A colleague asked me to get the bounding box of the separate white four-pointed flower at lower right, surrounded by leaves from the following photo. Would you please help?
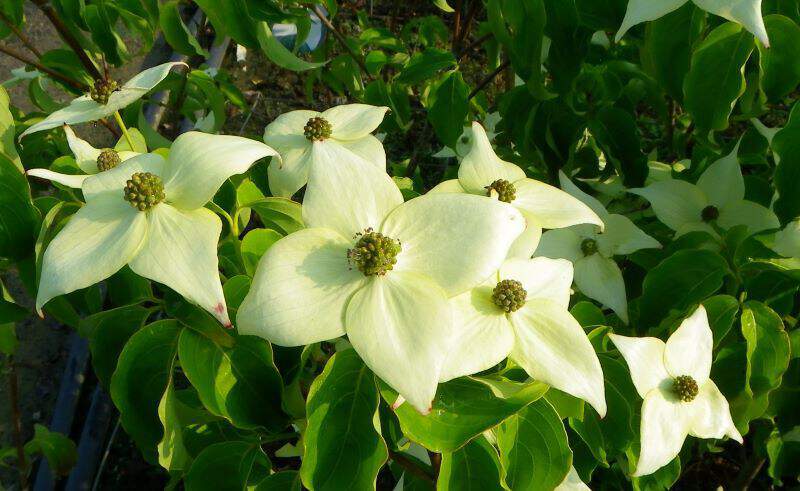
[609,305,742,476]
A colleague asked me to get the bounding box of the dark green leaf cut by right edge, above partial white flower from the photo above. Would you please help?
[772,103,800,224]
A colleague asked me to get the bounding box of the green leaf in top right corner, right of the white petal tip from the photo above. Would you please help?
[758,15,800,102]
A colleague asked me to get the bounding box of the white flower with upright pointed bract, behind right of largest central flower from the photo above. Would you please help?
[430,123,603,258]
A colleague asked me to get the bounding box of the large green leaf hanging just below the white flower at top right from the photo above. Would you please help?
[683,22,754,131]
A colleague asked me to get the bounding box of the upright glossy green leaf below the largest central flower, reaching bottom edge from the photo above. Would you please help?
[300,349,389,491]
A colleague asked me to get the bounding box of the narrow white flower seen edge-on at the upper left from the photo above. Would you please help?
[20,62,186,138]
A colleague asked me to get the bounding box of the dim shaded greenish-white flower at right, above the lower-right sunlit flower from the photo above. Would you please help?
[629,144,780,237]
